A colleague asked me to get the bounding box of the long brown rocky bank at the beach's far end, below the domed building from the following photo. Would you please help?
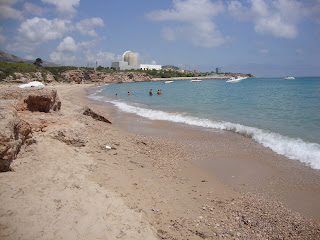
[62,69,151,84]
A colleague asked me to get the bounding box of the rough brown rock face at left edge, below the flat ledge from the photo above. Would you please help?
[0,106,32,172]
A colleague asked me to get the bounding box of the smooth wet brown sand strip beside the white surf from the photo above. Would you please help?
[88,86,320,221]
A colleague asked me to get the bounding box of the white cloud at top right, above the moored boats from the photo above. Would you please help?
[228,0,307,39]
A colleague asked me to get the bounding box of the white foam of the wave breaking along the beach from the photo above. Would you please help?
[110,101,320,169]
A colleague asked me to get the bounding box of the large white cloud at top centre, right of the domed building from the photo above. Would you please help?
[147,0,226,48]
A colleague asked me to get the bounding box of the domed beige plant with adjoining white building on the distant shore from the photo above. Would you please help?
[111,51,162,70]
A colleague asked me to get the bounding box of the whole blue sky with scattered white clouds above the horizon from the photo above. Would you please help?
[0,0,320,77]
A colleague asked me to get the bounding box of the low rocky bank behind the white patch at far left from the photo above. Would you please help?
[3,72,54,83]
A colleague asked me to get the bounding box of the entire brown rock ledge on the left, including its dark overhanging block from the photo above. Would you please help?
[0,87,61,171]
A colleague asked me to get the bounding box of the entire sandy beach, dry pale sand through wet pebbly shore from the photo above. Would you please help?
[0,84,320,239]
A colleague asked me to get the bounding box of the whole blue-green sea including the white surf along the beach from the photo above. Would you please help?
[91,77,320,169]
